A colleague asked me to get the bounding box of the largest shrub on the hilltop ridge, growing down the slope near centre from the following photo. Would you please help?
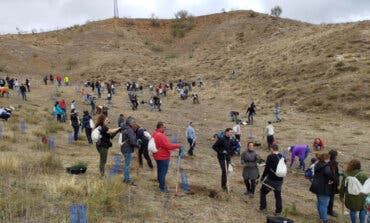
[171,10,195,38]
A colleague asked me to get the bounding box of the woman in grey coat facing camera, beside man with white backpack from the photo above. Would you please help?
[241,142,262,198]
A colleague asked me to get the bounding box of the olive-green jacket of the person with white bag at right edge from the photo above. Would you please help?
[339,170,368,211]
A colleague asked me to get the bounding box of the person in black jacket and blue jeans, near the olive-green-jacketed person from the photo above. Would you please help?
[310,153,334,223]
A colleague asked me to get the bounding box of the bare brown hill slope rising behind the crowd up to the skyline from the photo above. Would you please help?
[0,11,370,118]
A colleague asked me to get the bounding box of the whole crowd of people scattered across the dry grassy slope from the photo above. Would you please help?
[0,75,368,223]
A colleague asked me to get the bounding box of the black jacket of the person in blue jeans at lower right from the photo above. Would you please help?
[310,162,334,196]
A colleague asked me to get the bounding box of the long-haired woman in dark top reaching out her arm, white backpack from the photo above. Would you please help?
[95,114,121,176]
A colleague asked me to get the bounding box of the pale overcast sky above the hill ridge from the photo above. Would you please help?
[0,0,370,34]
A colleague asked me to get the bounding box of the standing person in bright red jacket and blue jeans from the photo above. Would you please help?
[152,122,181,193]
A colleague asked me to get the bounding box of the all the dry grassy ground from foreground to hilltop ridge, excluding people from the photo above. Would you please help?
[0,11,370,223]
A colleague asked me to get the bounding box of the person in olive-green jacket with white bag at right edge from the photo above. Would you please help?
[339,159,368,223]
